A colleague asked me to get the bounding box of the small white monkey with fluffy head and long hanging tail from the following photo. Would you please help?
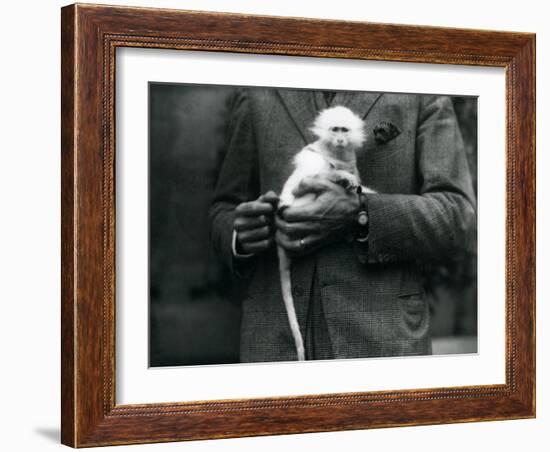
[277,106,374,361]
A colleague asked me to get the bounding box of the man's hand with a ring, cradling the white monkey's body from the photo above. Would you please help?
[275,177,359,255]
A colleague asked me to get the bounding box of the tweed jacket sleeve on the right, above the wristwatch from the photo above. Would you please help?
[367,96,477,262]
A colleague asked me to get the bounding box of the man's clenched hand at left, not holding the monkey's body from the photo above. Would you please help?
[233,191,279,254]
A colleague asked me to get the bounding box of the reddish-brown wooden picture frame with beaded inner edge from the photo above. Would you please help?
[61,4,535,447]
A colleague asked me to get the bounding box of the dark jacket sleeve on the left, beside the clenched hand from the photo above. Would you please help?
[209,89,259,277]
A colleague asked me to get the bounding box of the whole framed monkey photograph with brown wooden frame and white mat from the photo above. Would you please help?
[61,4,535,447]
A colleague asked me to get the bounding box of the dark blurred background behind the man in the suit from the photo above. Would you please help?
[149,83,477,367]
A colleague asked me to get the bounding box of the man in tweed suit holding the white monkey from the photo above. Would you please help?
[210,88,476,362]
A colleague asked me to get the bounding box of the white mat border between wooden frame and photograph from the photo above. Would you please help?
[116,48,506,404]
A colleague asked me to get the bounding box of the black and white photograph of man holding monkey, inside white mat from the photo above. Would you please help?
[148,85,478,367]
